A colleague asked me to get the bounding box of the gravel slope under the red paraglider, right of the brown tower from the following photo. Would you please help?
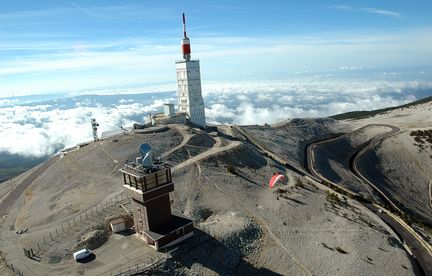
[169,138,413,275]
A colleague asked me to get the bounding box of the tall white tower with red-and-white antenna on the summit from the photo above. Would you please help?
[176,14,207,128]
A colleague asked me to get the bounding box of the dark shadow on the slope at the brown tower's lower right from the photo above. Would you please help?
[170,229,281,275]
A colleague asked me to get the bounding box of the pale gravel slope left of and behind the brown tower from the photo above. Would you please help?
[11,127,181,228]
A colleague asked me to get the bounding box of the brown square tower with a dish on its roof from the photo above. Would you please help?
[120,144,194,250]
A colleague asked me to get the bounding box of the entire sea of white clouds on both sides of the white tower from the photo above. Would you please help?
[0,80,432,157]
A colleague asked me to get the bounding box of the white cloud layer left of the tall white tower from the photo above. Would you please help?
[0,100,164,156]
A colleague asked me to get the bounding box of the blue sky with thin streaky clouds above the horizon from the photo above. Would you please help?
[0,0,432,97]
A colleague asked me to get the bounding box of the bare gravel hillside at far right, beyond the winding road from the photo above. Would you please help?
[350,102,432,226]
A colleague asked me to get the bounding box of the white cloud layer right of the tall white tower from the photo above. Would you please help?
[204,80,432,125]
